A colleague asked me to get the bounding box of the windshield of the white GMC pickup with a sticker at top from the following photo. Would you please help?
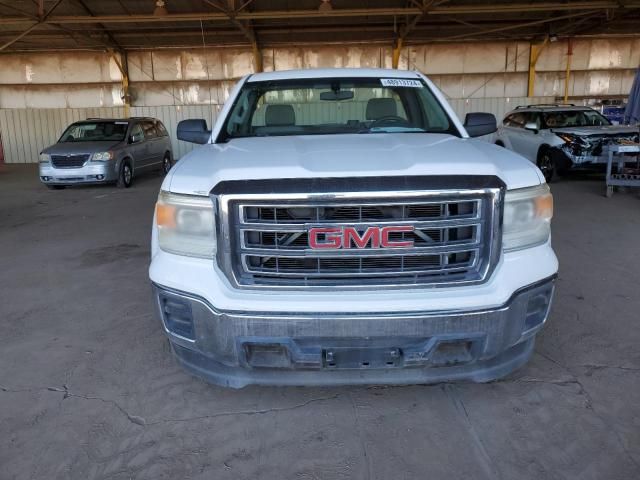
[218,78,459,141]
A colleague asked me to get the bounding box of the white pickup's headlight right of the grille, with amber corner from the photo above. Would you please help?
[502,183,553,251]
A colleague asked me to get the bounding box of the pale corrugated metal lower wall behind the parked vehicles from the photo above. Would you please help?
[0,97,553,163]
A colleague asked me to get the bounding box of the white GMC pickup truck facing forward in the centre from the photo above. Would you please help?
[149,69,558,387]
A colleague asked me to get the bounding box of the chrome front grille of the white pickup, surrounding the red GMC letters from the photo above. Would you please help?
[217,179,501,288]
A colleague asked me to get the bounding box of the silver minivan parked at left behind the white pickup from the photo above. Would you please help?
[40,117,173,189]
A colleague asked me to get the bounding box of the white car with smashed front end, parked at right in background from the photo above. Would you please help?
[495,105,638,182]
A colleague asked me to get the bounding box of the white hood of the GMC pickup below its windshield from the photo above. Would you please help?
[162,133,543,195]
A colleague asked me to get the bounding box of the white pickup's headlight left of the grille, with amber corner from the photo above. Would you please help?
[156,191,216,258]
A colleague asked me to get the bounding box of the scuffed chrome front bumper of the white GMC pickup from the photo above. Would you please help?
[153,278,554,388]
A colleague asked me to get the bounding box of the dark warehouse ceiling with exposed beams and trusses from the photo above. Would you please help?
[0,0,640,53]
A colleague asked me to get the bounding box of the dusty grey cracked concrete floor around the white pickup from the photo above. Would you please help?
[0,166,640,480]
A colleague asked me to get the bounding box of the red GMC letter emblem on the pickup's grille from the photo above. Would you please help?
[309,225,414,250]
